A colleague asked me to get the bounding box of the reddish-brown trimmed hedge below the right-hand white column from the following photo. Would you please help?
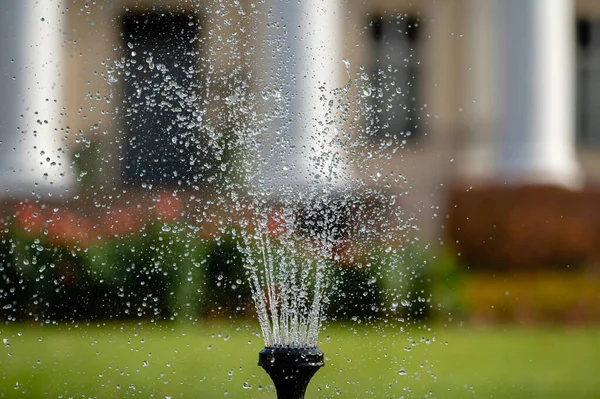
[446,186,600,270]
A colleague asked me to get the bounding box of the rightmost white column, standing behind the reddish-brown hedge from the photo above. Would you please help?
[496,0,581,186]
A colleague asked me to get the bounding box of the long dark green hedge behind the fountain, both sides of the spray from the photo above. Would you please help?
[0,211,436,320]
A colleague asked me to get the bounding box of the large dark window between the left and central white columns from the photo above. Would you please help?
[123,12,200,185]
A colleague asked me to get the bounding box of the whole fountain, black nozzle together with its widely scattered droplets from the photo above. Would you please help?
[0,0,426,399]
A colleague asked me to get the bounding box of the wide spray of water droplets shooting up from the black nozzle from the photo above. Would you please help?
[95,0,422,347]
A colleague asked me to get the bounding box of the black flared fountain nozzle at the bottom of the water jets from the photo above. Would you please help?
[258,347,325,399]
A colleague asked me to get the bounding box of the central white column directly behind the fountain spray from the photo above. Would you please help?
[258,0,348,195]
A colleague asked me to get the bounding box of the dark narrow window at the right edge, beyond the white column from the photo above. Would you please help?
[577,20,600,146]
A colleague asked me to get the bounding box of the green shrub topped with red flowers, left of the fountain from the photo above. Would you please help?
[0,196,207,319]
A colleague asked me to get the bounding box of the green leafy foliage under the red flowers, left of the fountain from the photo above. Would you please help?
[0,221,209,319]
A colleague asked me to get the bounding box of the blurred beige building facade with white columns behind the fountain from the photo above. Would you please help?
[0,0,600,236]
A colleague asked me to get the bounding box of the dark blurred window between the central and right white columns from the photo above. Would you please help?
[368,14,422,142]
